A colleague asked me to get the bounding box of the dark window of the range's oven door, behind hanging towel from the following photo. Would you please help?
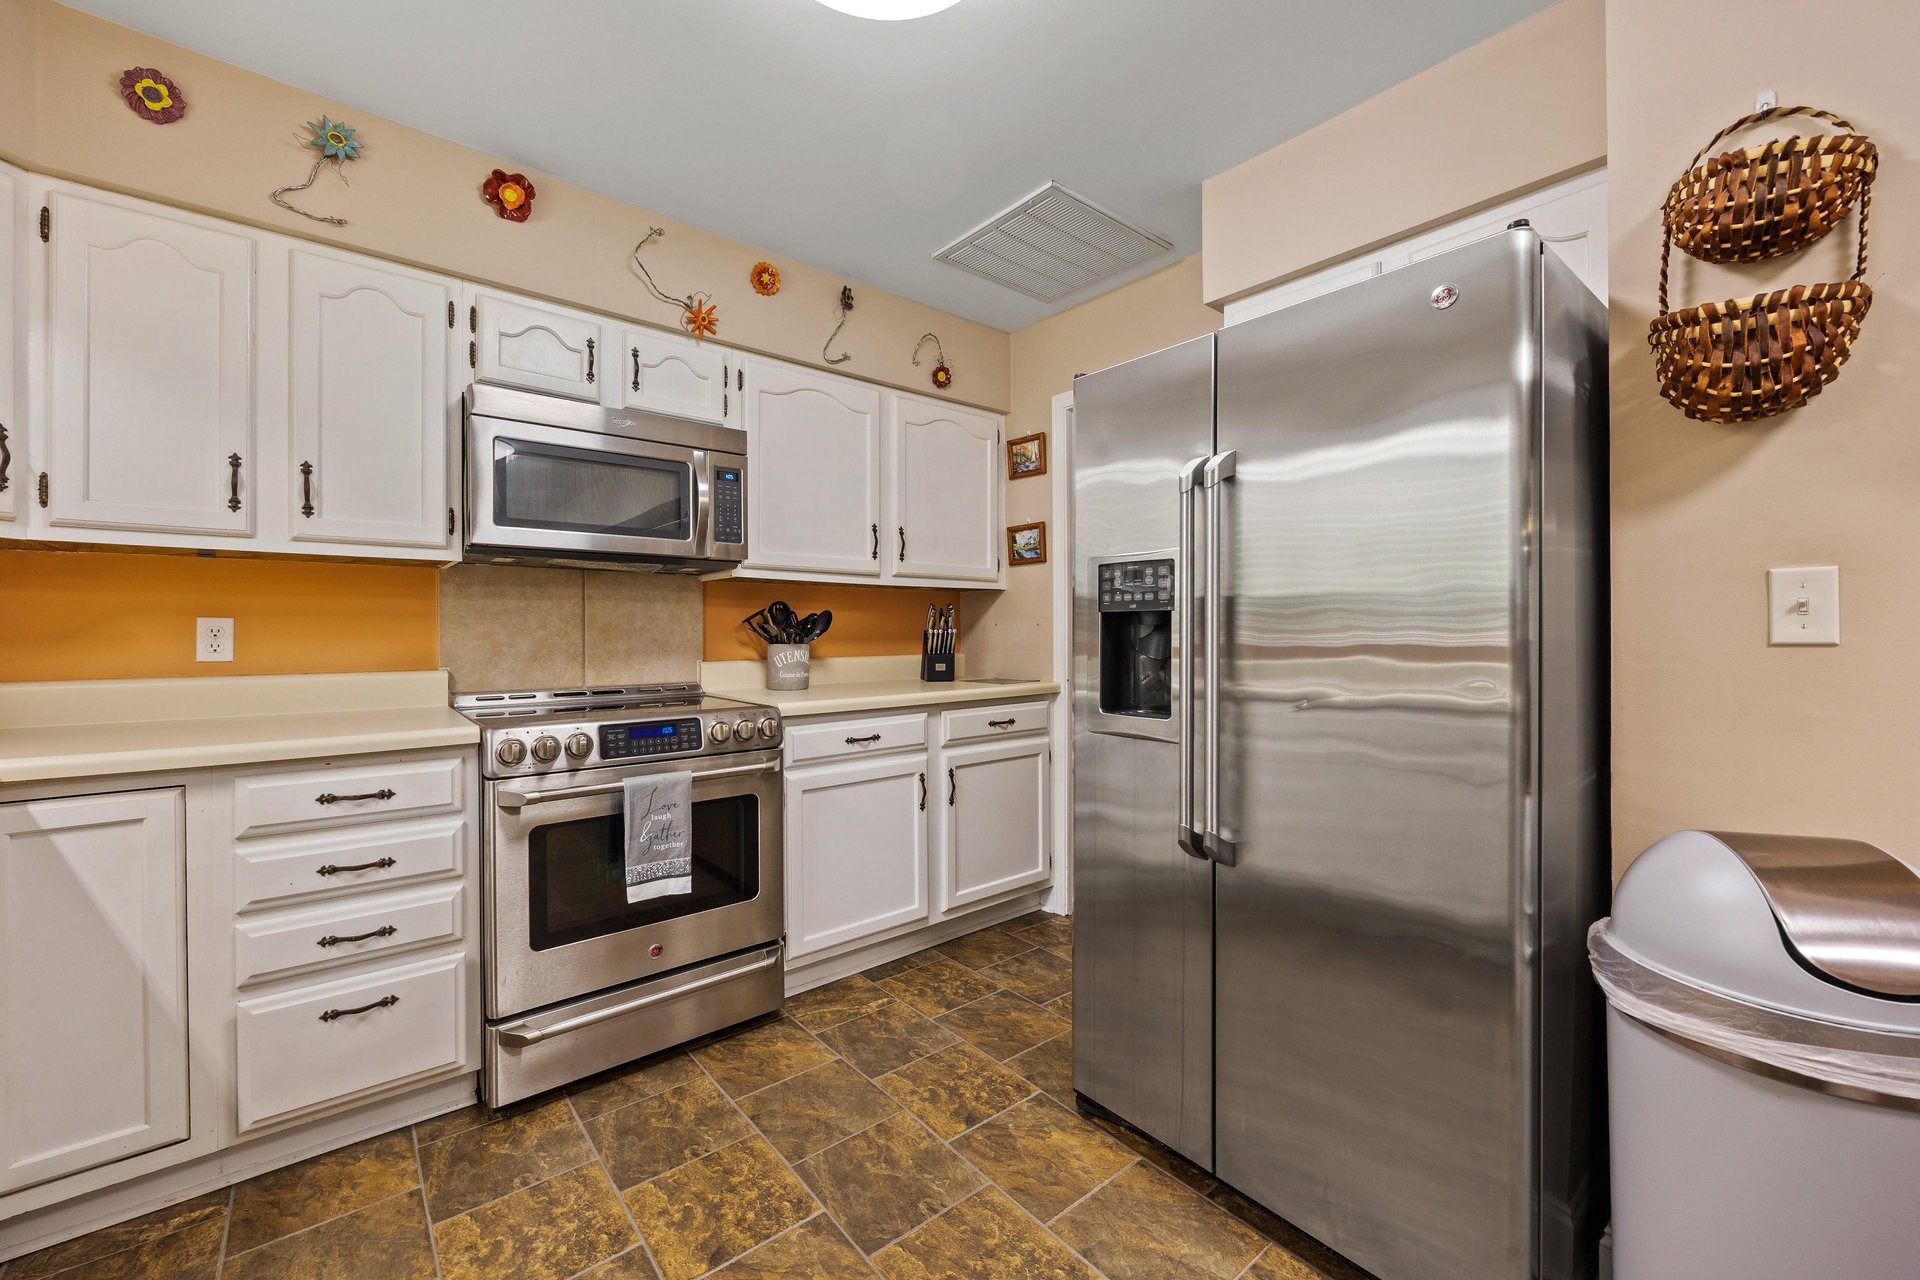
[526,794,760,952]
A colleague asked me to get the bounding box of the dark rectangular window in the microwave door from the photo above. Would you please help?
[493,439,693,541]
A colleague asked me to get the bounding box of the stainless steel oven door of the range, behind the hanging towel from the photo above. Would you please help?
[486,750,785,1019]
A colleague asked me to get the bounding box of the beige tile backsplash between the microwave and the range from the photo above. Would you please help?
[440,564,701,693]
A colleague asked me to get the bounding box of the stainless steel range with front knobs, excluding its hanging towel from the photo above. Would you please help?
[453,685,783,1107]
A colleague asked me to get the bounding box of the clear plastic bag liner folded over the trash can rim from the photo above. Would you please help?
[1586,919,1920,1107]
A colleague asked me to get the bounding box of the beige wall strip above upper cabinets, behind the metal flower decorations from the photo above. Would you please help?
[0,0,1008,409]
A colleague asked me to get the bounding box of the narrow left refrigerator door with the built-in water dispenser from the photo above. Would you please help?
[1073,338,1213,1165]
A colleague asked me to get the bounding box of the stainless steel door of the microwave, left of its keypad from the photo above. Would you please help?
[467,415,712,560]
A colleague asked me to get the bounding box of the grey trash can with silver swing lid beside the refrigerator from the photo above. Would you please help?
[1588,831,1920,1280]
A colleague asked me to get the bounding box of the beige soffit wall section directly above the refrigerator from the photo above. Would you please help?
[1202,0,1612,307]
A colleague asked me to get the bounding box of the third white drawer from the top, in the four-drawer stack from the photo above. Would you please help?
[234,881,465,986]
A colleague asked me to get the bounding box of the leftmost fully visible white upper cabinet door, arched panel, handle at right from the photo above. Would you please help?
[46,192,255,535]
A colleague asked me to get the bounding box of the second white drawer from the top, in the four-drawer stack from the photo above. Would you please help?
[234,818,467,912]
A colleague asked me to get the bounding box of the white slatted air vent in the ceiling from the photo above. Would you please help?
[933,182,1173,301]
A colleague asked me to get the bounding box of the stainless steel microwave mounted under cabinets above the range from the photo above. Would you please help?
[465,386,747,574]
